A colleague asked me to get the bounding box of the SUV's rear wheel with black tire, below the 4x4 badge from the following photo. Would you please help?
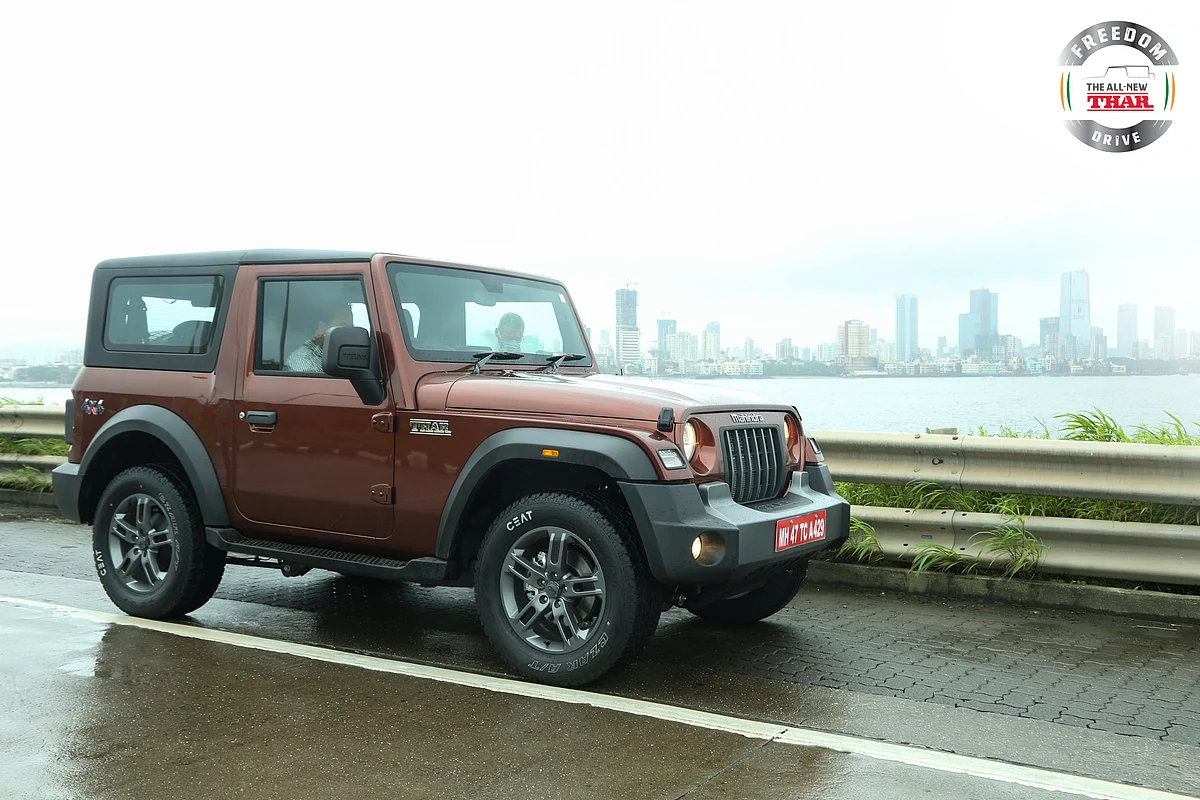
[91,467,226,619]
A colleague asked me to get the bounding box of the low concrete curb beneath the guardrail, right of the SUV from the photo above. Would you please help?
[808,561,1200,622]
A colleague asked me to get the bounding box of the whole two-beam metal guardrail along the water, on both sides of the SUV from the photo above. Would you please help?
[0,405,1200,585]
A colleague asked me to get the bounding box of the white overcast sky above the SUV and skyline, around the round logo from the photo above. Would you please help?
[0,0,1200,357]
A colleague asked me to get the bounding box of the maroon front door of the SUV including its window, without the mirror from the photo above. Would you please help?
[226,271,395,540]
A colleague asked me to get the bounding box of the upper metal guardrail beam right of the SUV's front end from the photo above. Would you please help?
[810,431,1200,505]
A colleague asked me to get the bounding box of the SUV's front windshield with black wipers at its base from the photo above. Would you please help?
[388,263,592,367]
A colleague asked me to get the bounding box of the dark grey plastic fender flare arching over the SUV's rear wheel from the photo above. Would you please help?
[79,404,229,525]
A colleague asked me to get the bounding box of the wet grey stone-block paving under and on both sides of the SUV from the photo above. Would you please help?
[9,521,1200,746]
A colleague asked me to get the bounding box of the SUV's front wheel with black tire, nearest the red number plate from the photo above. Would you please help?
[475,492,661,686]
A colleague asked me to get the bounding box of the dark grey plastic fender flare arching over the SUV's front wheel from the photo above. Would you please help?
[436,428,660,559]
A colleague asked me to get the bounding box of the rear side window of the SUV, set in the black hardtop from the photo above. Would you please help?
[104,276,223,353]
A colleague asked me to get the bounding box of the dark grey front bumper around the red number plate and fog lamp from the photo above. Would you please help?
[620,463,850,584]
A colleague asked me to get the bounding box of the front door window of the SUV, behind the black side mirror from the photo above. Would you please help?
[254,278,371,375]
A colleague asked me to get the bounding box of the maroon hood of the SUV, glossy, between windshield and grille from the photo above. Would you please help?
[446,372,791,421]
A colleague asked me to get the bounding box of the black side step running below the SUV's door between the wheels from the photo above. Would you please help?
[204,528,456,585]
